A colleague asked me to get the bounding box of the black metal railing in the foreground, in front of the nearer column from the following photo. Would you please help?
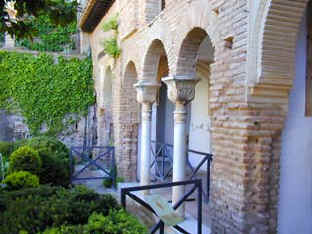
[121,180,202,234]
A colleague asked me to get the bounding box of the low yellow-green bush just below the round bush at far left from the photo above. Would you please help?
[3,171,39,191]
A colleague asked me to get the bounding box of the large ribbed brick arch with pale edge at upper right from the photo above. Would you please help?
[248,0,309,93]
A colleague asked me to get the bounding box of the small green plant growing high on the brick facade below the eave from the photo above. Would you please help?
[102,14,121,59]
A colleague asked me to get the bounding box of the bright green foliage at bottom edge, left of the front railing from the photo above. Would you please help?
[43,210,148,234]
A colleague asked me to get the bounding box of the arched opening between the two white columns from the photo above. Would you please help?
[143,39,174,180]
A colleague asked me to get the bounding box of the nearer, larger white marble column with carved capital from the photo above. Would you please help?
[162,76,199,216]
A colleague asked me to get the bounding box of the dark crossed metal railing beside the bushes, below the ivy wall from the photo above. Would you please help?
[70,146,116,185]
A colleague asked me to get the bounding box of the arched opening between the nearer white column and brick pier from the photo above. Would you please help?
[176,28,214,226]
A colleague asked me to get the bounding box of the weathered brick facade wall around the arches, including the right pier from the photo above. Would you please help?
[85,0,303,234]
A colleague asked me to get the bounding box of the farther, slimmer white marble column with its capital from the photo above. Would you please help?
[134,80,160,194]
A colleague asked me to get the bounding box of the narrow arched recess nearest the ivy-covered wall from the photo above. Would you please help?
[97,66,114,146]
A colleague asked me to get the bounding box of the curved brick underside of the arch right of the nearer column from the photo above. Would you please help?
[176,28,214,77]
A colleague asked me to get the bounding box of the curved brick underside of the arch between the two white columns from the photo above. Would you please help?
[142,39,167,81]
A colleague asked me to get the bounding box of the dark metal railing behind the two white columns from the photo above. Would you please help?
[151,141,213,202]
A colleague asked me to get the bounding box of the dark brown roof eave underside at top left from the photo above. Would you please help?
[79,0,115,33]
